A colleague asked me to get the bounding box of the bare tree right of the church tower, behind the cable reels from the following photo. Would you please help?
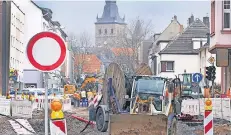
[112,17,152,73]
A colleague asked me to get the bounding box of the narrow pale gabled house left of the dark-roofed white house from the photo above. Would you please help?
[148,15,183,75]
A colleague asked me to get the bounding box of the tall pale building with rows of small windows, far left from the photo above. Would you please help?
[10,1,26,89]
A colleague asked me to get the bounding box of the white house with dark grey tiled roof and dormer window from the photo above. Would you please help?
[158,16,209,78]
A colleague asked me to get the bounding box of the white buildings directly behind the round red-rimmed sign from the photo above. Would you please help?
[19,1,69,88]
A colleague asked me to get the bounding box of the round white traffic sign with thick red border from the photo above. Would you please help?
[27,32,67,72]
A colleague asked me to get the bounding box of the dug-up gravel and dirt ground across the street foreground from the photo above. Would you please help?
[0,108,231,135]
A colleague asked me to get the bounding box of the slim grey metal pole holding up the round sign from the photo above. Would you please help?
[44,72,49,135]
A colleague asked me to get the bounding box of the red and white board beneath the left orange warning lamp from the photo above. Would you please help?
[50,119,67,135]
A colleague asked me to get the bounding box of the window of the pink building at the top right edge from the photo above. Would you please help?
[223,0,231,29]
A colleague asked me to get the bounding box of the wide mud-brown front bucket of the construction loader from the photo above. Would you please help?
[109,114,168,135]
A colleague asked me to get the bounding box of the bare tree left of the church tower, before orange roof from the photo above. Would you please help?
[68,32,92,80]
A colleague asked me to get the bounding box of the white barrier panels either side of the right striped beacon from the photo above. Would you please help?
[181,98,231,121]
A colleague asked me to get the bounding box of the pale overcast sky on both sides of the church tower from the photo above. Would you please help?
[35,0,210,40]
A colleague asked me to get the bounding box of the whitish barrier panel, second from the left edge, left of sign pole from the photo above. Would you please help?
[12,100,33,118]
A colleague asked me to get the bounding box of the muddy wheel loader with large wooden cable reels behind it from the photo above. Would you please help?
[92,63,181,135]
